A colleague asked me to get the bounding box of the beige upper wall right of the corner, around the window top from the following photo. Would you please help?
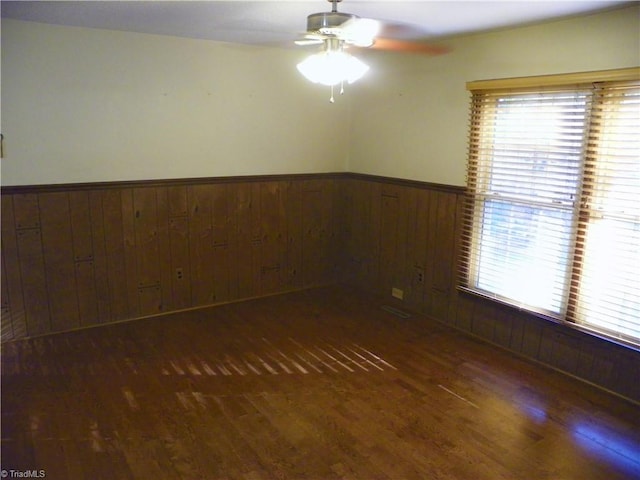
[347,4,640,185]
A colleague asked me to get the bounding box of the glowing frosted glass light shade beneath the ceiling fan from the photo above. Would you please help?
[297,50,369,86]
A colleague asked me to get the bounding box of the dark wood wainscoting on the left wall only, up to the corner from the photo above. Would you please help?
[2,174,340,341]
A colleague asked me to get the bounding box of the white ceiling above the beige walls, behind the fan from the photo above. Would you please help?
[1,0,630,46]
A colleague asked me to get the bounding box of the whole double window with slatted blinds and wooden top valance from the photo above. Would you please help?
[461,69,640,345]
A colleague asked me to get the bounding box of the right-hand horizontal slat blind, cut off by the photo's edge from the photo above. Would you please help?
[569,83,640,343]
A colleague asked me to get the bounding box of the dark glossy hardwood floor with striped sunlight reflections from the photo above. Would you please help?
[2,287,640,480]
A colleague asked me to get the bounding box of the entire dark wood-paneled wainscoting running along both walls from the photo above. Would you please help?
[2,173,640,402]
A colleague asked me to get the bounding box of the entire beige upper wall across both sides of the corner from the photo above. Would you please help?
[2,4,640,185]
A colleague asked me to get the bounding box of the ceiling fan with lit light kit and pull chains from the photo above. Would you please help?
[295,0,447,103]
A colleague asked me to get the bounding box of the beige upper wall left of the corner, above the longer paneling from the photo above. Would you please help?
[2,20,349,185]
